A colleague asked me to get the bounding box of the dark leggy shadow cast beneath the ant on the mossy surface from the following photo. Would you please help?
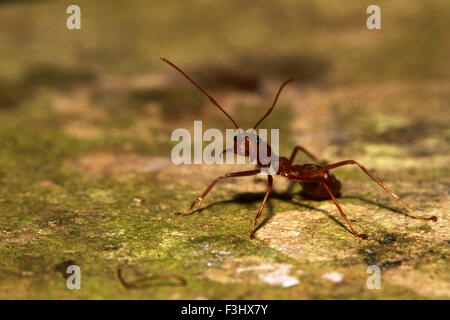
[190,183,413,235]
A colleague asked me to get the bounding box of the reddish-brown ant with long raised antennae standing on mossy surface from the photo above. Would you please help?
[161,58,437,239]
